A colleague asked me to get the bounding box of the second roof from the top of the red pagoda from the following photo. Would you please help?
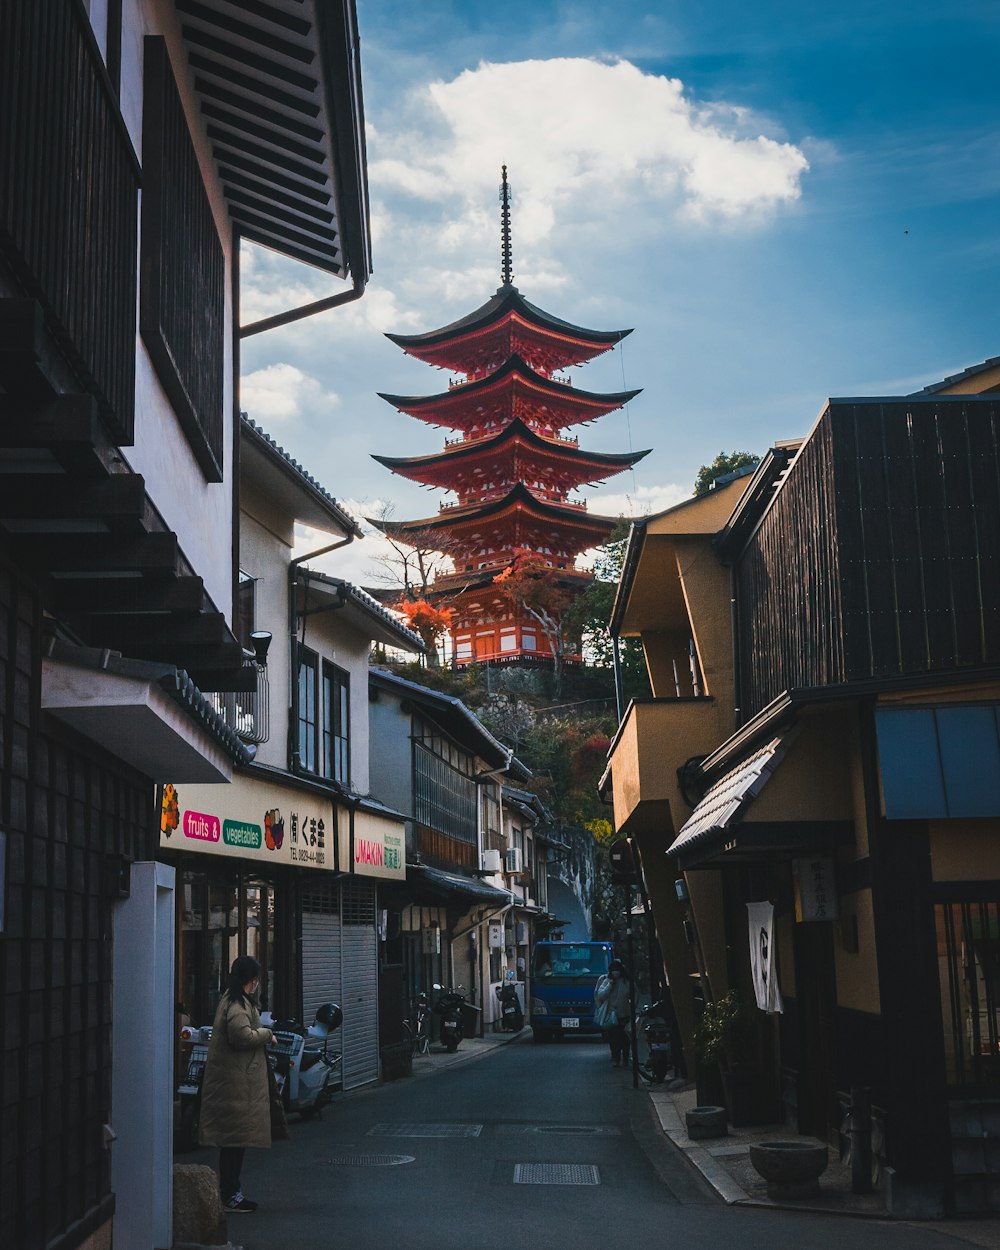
[379,356,641,434]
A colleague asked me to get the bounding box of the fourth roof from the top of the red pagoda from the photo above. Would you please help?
[370,483,618,560]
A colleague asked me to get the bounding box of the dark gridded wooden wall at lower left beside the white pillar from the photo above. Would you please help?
[0,569,155,1250]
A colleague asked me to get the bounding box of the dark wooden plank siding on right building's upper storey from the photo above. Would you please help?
[736,396,1000,715]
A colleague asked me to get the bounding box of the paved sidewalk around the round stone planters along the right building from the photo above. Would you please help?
[650,1084,1000,1250]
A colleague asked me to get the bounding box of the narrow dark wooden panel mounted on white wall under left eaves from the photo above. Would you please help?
[139,35,225,481]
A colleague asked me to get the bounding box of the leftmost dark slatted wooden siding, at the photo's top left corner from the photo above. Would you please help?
[0,0,139,444]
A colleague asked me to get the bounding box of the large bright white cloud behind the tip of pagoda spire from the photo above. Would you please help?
[370,58,809,236]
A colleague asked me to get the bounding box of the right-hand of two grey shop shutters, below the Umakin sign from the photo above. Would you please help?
[341,879,379,1090]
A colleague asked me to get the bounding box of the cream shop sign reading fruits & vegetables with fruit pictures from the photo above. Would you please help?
[160,778,336,869]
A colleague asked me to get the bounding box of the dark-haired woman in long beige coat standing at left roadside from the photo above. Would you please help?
[200,955,274,1214]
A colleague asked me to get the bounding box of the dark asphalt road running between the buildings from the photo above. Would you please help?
[191,1035,968,1250]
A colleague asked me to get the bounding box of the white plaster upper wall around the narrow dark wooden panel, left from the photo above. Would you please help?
[116,0,234,620]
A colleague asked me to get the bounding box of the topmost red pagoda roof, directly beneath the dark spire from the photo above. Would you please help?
[386,283,631,375]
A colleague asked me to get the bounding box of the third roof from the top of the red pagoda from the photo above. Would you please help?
[373,418,649,495]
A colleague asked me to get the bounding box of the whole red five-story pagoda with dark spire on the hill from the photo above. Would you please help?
[374,166,648,665]
